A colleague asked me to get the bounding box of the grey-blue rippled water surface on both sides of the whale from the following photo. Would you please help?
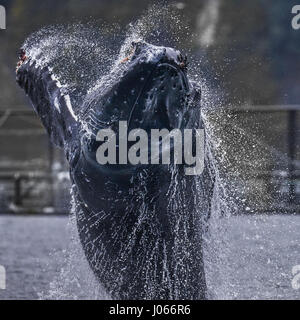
[0,215,300,299]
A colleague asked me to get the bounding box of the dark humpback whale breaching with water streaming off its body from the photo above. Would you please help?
[17,41,214,300]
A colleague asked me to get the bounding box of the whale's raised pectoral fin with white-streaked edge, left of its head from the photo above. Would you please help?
[16,55,78,147]
